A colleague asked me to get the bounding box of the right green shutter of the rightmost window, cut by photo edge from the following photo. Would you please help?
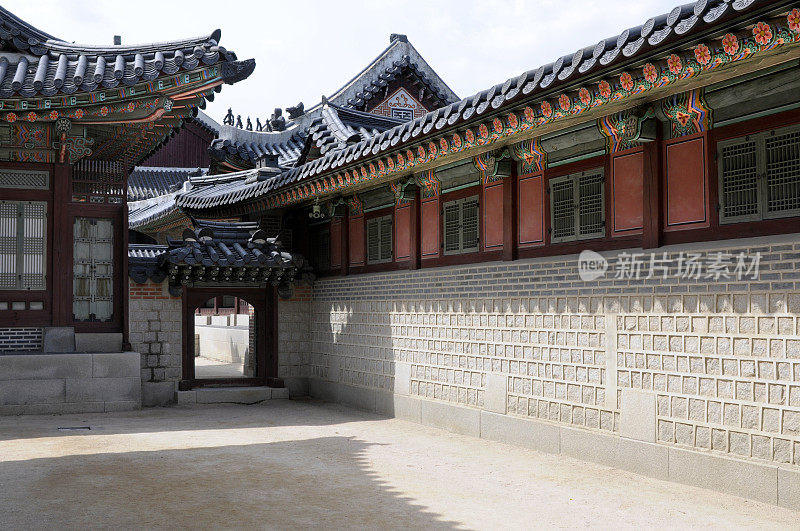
[764,129,800,217]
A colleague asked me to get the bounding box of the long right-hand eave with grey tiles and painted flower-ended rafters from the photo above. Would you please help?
[178,0,800,215]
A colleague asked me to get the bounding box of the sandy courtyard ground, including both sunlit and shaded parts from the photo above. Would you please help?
[0,400,798,529]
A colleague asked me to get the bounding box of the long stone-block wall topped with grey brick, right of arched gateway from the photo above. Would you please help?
[308,235,800,504]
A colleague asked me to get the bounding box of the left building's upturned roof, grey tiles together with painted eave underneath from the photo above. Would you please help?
[0,8,255,167]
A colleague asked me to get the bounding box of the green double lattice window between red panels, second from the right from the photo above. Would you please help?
[549,169,605,243]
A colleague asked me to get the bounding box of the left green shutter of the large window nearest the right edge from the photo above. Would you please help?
[719,138,760,223]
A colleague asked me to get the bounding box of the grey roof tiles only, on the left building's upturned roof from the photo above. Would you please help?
[0,8,255,97]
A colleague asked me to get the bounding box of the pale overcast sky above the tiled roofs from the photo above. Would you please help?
[3,0,678,123]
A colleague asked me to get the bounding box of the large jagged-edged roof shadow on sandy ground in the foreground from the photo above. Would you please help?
[0,437,455,529]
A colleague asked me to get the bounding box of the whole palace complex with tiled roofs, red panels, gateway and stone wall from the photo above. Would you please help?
[0,0,800,504]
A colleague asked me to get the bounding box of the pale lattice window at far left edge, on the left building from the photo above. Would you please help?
[0,201,47,290]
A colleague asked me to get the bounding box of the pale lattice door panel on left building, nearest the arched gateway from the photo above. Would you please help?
[72,217,114,322]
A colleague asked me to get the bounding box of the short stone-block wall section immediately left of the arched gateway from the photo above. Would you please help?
[129,280,182,406]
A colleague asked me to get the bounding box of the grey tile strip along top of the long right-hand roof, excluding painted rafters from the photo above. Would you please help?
[177,0,792,214]
